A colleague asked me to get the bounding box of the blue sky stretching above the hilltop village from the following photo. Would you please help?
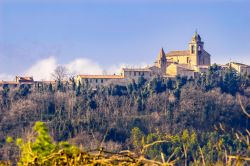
[0,0,250,79]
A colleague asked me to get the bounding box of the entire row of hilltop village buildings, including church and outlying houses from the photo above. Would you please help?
[0,32,250,88]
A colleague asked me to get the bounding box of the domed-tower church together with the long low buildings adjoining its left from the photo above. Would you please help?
[77,32,211,87]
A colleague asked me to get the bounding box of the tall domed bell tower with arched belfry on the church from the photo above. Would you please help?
[189,31,204,66]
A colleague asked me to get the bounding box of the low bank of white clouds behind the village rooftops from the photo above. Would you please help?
[0,56,147,81]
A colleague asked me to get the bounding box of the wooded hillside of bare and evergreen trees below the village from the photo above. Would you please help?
[0,65,250,165]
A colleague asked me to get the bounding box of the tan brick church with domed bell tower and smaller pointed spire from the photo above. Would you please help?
[152,32,211,77]
